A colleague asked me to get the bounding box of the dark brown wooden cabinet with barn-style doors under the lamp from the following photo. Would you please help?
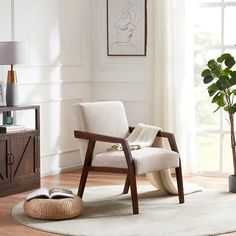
[0,106,40,197]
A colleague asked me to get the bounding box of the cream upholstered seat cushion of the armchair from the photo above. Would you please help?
[92,147,179,174]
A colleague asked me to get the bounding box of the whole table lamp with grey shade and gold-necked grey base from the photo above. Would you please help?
[0,41,27,106]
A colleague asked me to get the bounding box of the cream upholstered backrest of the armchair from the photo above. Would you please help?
[77,101,129,161]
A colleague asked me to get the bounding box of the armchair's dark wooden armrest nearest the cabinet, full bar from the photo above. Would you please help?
[74,130,125,144]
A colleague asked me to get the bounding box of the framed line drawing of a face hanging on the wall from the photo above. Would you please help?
[107,0,147,56]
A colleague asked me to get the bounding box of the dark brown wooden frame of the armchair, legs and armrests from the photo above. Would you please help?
[74,127,184,214]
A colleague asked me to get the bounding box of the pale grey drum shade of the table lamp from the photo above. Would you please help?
[0,41,27,65]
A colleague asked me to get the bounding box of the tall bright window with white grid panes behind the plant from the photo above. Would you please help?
[194,0,236,174]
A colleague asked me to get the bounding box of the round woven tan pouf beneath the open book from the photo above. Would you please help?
[24,196,83,220]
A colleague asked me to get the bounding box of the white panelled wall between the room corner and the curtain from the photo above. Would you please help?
[91,0,151,125]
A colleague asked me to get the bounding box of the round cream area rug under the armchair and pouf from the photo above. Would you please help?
[11,185,236,236]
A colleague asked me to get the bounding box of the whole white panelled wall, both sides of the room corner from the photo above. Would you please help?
[0,0,151,174]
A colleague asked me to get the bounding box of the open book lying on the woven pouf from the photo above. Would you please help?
[26,188,74,201]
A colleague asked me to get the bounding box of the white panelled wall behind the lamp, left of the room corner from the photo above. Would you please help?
[0,0,91,174]
